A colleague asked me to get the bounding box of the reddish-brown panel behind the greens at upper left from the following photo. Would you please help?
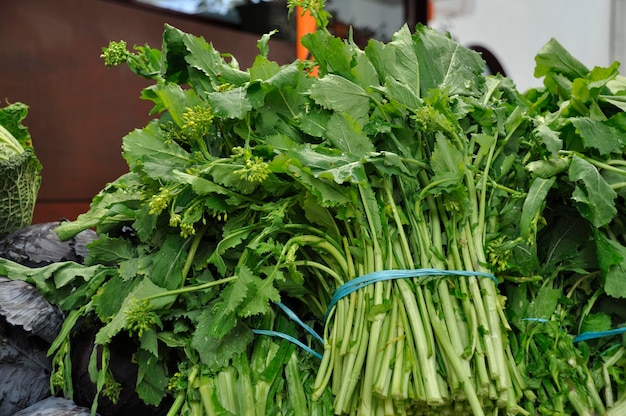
[0,0,295,223]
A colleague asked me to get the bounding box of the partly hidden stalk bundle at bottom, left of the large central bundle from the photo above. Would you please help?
[168,311,332,416]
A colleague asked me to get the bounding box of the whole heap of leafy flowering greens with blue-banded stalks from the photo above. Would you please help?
[0,1,626,415]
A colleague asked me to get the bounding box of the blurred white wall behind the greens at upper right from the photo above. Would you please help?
[430,0,612,91]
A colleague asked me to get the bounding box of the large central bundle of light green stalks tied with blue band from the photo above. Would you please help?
[292,70,524,414]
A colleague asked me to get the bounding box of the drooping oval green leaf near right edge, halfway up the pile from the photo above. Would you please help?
[568,156,617,227]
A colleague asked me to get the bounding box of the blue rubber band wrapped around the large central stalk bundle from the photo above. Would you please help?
[324,269,498,322]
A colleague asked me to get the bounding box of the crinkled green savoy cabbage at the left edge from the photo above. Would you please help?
[0,103,41,237]
